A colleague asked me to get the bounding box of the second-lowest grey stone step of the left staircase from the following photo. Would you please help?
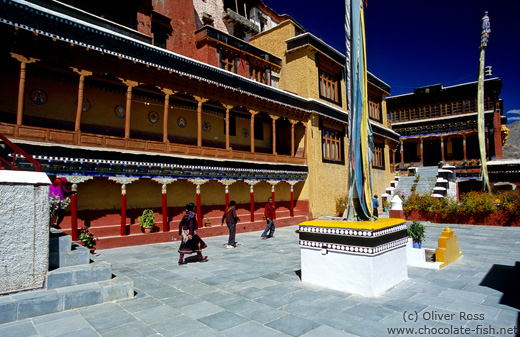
[45,261,112,289]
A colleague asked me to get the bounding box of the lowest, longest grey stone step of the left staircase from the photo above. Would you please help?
[0,276,134,324]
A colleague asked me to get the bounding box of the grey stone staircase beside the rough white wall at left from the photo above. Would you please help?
[0,229,134,324]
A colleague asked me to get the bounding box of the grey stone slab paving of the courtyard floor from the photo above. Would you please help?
[0,219,520,337]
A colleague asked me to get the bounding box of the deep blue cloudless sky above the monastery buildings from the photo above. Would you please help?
[264,0,520,123]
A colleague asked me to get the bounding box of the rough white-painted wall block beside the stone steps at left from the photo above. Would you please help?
[0,170,51,294]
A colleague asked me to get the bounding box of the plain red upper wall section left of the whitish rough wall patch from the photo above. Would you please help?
[152,0,198,59]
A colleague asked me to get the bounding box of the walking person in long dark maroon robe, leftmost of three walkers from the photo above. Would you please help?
[179,202,208,265]
